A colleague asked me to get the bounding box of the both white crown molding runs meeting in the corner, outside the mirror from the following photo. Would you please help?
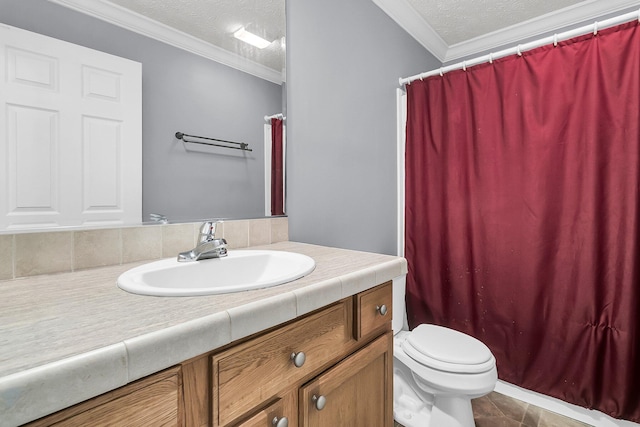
[372,0,640,63]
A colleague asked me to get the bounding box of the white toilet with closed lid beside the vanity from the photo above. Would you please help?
[393,276,498,427]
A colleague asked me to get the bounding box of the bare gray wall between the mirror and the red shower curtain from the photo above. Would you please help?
[287,0,441,254]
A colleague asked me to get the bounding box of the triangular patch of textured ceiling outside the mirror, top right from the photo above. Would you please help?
[407,0,584,46]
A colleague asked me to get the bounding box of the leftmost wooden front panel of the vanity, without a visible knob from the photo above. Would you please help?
[27,367,183,427]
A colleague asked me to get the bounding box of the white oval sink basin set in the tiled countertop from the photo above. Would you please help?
[118,250,316,296]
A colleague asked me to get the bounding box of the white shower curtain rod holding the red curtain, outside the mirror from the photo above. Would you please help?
[399,10,640,87]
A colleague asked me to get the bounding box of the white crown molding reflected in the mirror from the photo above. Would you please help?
[49,0,284,84]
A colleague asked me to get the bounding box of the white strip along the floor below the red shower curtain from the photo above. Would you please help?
[495,380,640,427]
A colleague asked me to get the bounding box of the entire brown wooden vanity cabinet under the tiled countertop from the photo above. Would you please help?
[29,282,393,427]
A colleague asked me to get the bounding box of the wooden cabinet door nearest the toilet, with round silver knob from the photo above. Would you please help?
[300,332,393,427]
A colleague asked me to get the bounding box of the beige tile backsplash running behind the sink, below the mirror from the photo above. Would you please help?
[0,217,289,281]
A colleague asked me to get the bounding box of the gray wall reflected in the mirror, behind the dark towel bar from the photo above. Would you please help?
[0,0,282,224]
